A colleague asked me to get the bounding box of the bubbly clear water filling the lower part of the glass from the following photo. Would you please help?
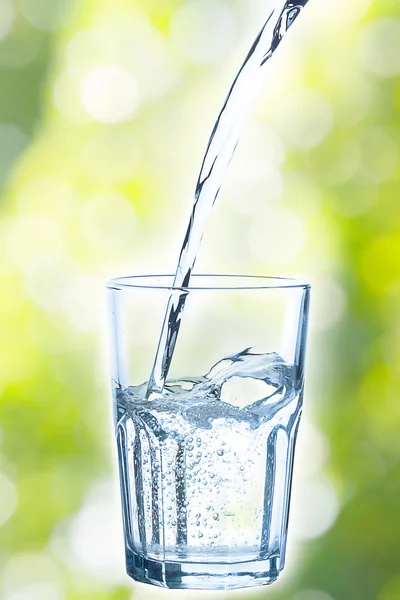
[117,355,300,560]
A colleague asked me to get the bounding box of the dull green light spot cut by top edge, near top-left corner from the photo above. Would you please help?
[17,0,76,31]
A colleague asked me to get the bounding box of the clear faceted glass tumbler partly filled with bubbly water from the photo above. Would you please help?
[107,275,310,589]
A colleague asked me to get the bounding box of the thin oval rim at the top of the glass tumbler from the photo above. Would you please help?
[106,273,311,292]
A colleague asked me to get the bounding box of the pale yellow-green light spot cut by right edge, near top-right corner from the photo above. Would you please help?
[360,18,400,77]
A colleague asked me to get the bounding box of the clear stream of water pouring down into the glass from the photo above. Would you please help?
[147,0,308,399]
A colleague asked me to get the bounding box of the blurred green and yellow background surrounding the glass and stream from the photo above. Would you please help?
[0,0,400,600]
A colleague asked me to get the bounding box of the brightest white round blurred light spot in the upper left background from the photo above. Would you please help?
[81,65,139,123]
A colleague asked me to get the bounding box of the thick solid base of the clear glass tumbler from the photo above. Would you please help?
[126,550,282,590]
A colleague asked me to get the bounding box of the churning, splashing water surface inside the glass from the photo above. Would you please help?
[116,348,296,435]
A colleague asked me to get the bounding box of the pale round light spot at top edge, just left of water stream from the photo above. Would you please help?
[171,0,236,64]
